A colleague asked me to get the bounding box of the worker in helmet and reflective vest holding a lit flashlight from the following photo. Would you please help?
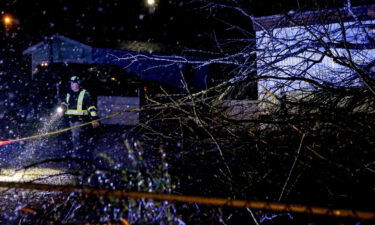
[57,76,99,159]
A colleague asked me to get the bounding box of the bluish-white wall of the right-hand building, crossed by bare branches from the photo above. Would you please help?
[256,20,375,97]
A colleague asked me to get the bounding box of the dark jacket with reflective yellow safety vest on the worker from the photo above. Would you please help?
[62,89,97,119]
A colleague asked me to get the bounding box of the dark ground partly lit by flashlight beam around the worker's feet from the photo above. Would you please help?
[0,120,135,224]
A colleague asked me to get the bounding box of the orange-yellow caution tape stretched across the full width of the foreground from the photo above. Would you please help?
[0,182,375,220]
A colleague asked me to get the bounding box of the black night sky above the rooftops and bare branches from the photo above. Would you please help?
[0,0,371,52]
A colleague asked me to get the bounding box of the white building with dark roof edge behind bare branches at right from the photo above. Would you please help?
[253,5,375,110]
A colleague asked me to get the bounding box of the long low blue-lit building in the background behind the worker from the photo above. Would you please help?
[23,35,207,89]
